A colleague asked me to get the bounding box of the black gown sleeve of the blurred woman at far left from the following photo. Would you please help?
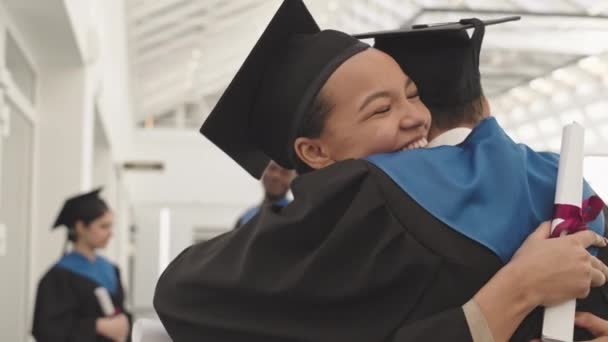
[32,269,97,342]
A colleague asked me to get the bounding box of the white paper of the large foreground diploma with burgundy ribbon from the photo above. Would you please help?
[542,122,585,342]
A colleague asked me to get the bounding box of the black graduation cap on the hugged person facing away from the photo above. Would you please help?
[355,16,520,110]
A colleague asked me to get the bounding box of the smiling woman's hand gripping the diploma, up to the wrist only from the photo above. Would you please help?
[508,222,608,306]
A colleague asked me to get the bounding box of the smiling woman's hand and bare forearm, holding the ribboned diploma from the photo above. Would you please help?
[473,222,608,341]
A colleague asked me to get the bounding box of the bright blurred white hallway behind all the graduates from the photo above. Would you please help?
[0,0,608,342]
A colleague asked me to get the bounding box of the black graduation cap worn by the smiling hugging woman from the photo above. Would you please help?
[200,0,369,178]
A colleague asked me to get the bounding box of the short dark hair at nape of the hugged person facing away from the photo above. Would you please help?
[428,94,485,129]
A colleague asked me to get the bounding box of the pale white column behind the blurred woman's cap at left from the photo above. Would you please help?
[31,66,90,283]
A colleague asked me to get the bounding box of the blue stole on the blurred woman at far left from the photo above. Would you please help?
[55,252,118,295]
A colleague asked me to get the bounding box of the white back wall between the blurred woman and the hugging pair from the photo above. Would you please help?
[124,129,262,311]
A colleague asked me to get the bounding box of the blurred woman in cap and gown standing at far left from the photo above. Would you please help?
[32,188,131,342]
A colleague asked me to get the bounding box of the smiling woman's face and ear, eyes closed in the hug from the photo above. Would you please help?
[296,48,431,169]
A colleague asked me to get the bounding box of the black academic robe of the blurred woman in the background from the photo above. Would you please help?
[32,266,132,342]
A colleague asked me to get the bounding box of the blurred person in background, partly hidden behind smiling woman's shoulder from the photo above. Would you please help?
[234,161,295,229]
